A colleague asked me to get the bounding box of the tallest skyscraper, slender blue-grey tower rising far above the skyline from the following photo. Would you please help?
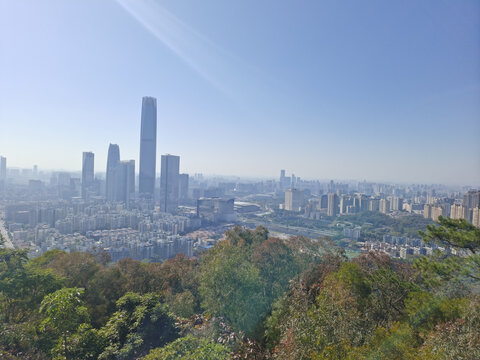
[138,97,157,197]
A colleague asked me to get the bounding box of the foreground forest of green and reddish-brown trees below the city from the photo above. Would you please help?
[0,218,480,360]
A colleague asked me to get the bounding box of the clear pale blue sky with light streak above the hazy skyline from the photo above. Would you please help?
[0,0,480,186]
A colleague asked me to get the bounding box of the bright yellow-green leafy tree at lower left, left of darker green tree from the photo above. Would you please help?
[40,288,89,360]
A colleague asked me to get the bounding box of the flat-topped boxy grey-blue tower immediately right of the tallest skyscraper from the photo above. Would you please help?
[160,154,180,213]
